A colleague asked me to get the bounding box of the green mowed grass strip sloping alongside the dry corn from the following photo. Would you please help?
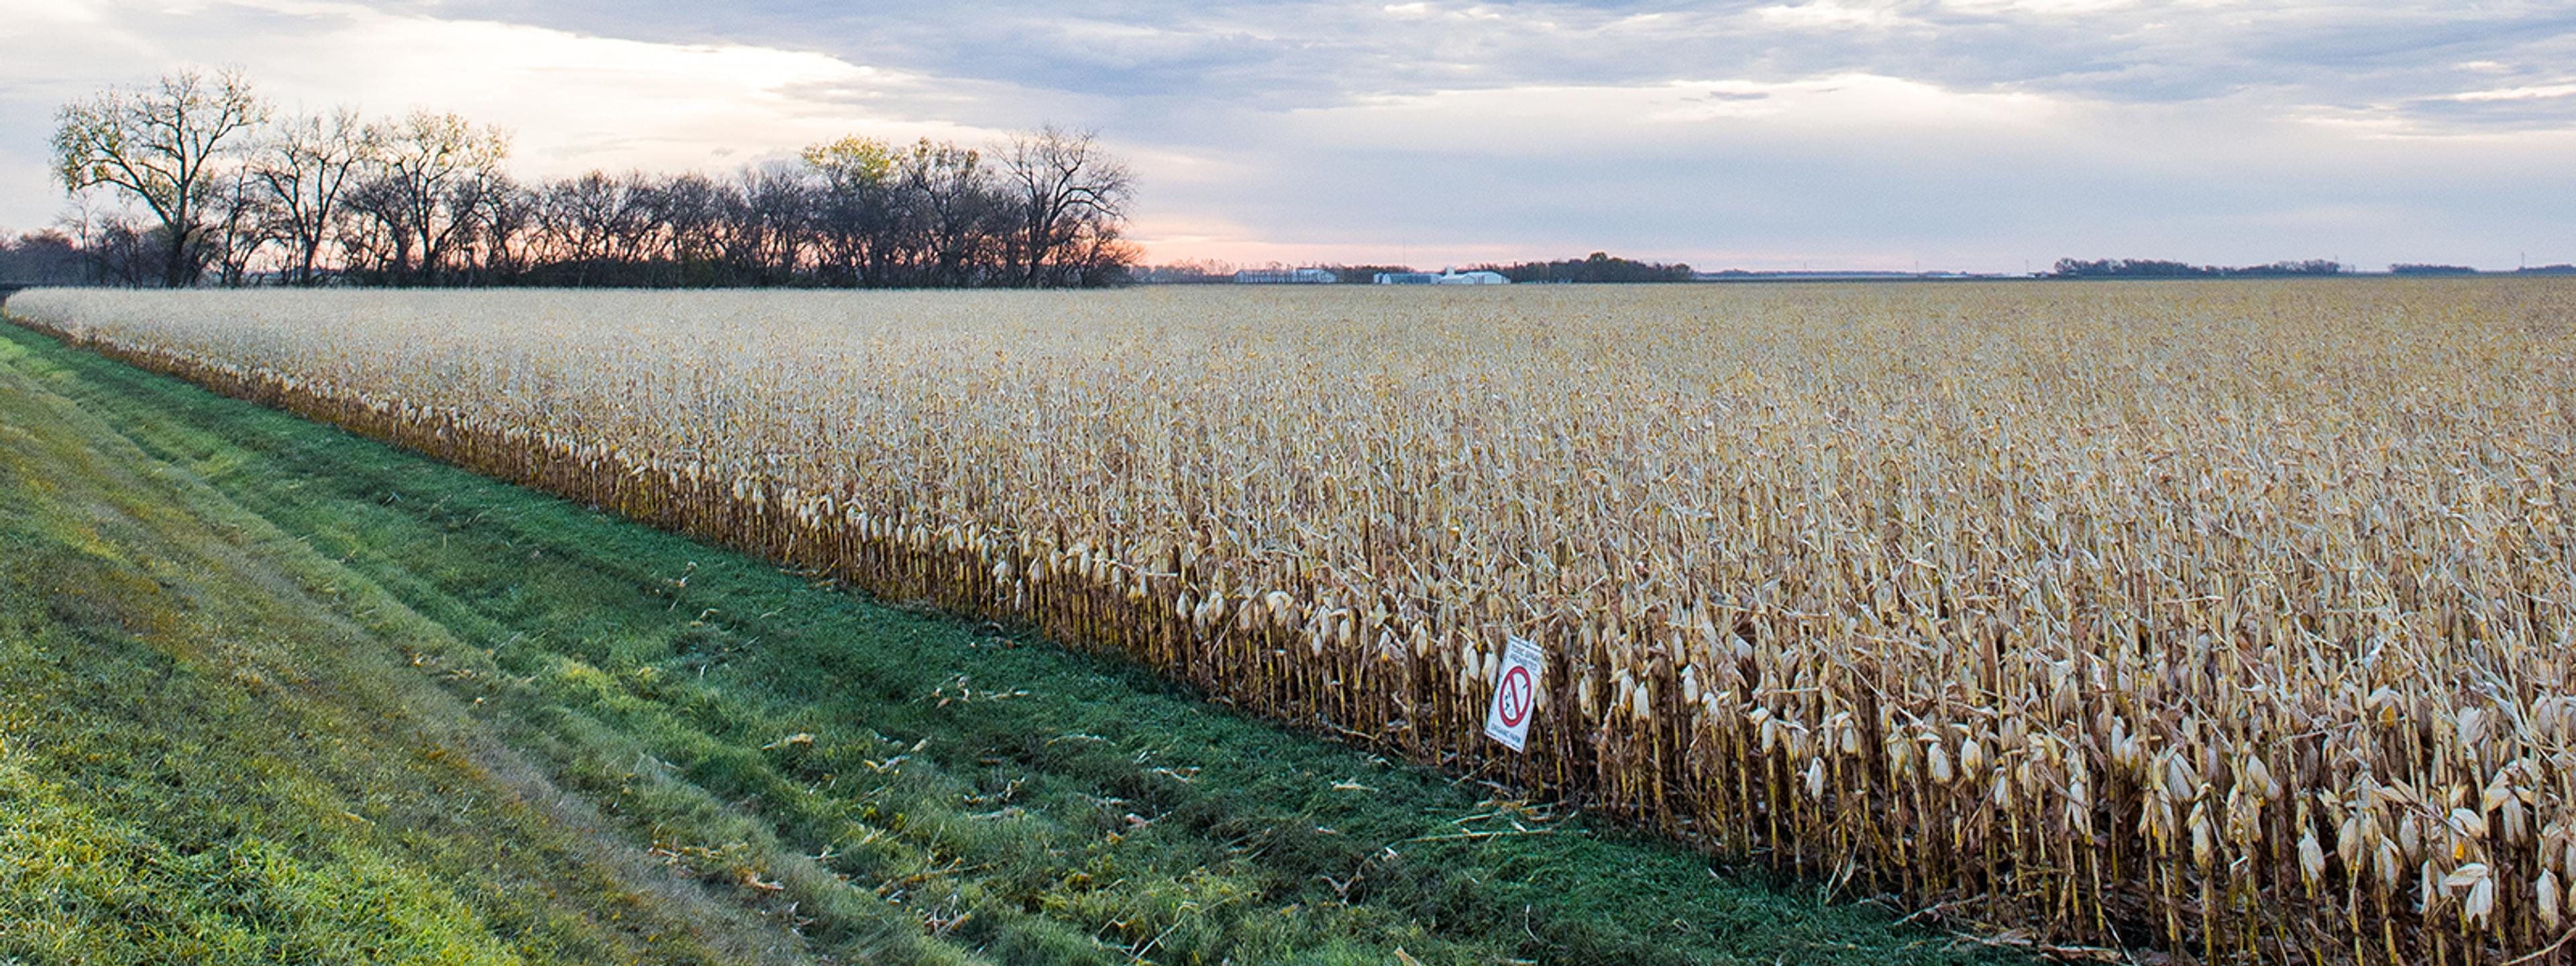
[0,325,1986,963]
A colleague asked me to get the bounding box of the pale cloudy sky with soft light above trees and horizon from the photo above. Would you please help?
[0,0,2576,270]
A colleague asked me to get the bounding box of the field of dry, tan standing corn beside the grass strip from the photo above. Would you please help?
[10,281,2576,963]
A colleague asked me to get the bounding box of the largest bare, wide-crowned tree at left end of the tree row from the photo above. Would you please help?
[54,70,268,286]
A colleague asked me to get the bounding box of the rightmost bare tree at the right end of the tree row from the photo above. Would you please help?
[1002,123,1134,286]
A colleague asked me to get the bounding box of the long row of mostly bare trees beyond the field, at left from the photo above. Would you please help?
[35,70,1138,288]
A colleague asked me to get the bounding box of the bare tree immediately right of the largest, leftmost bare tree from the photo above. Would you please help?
[250,108,381,286]
